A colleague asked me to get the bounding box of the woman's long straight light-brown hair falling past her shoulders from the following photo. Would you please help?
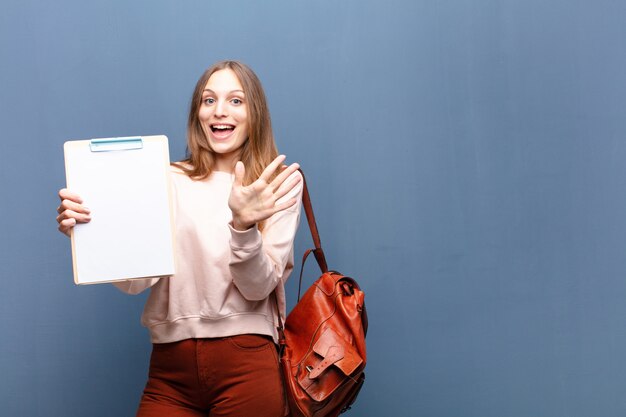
[176,61,278,185]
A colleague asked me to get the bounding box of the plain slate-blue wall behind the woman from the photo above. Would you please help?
[0,0,626,417]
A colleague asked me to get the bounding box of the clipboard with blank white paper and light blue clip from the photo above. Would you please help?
[63,136,175,285]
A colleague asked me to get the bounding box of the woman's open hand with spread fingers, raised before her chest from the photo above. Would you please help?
[228,155,301,230]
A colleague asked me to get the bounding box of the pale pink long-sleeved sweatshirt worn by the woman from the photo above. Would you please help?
[114,167,302,343]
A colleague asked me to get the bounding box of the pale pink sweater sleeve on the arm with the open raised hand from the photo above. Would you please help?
[229,171,303,300]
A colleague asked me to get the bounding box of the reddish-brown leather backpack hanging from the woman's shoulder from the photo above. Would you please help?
[278,171,367,417]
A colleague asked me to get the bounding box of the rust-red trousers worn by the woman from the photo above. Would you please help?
[137,335,285,417]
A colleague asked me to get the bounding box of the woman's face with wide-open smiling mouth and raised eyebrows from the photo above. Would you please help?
[198,69,248,169]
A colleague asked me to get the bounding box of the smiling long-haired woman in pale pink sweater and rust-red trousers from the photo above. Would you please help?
[57,61,302,417]
